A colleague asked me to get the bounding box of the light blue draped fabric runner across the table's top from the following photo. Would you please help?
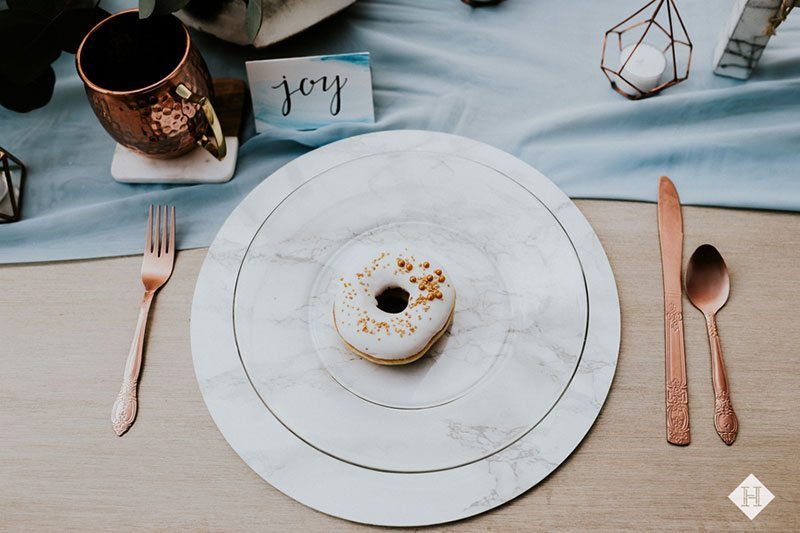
[0,0,800,262]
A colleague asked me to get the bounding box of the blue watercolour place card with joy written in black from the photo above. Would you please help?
[246,52,375,133]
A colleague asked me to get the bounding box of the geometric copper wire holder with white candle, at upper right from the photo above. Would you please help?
[600,0,692,100]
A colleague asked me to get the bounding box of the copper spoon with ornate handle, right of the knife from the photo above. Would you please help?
[686,244,739,446]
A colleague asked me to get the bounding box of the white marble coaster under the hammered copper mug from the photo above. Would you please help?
[111,137,239,183]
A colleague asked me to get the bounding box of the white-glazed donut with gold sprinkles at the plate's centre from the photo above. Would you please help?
[333,249,456,365]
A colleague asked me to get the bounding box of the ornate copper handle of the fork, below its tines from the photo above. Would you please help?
[111,290,155,436]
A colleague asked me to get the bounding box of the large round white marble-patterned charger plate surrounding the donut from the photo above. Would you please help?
[191,131,620,526]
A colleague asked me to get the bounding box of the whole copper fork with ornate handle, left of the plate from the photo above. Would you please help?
[111,205,175,436]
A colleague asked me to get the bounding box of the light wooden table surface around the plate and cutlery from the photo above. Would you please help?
[0,201,800,531]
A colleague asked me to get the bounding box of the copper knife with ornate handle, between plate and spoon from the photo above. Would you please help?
[658,176,691,446]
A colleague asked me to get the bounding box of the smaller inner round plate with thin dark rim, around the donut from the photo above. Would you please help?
[234,152,586,472]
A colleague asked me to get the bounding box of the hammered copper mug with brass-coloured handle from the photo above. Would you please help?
[75,9,226,160]
